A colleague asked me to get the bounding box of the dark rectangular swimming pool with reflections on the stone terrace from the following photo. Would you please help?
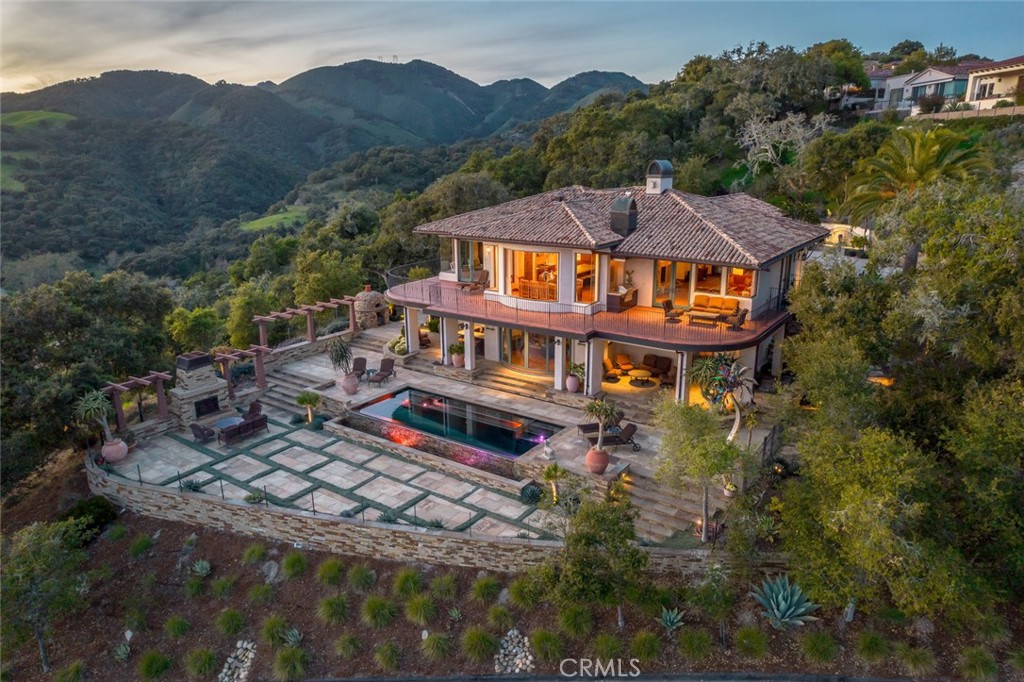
[355,388,562,459]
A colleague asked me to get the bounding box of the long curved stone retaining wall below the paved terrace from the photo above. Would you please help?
[85,457,785,574]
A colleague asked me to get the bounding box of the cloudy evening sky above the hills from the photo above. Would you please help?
[0,0,1024,92]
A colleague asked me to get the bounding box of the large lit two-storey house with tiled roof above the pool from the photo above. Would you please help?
[386,161,828,402]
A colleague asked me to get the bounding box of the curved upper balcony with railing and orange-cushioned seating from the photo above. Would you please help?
[386,261,790,351]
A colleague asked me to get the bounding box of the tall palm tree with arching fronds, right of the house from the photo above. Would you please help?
[842,128,988,272]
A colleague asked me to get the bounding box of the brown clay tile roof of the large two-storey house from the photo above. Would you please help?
[416,185,828,268]
